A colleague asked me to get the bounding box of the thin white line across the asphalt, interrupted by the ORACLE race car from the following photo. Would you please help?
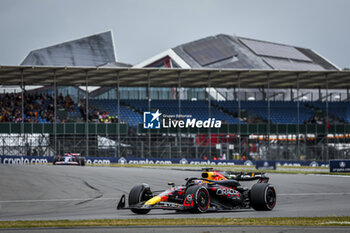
[0,193,350,203]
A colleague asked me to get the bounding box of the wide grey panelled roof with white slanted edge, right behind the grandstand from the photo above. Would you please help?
[135,34,339,71]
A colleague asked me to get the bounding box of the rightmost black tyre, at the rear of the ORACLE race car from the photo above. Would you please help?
[250,183,277,210]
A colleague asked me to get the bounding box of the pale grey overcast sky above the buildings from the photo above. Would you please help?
[0,0,350,68]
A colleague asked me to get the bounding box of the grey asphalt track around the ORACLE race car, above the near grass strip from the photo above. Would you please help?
[0,165,350,220]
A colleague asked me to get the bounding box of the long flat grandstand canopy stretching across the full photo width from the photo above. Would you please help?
[0,66,350,89]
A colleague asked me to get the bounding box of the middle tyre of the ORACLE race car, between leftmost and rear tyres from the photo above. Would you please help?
[185,185,210,213]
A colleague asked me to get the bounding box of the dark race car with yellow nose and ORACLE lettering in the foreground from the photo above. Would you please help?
[117,168,276,214]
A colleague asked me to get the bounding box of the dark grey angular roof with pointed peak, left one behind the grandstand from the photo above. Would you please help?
[21,31,117,67]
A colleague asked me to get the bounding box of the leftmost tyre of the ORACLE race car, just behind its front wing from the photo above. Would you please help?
[128,184,152,214]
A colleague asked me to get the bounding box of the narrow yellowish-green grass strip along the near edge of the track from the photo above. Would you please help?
[0,216,350,228]
